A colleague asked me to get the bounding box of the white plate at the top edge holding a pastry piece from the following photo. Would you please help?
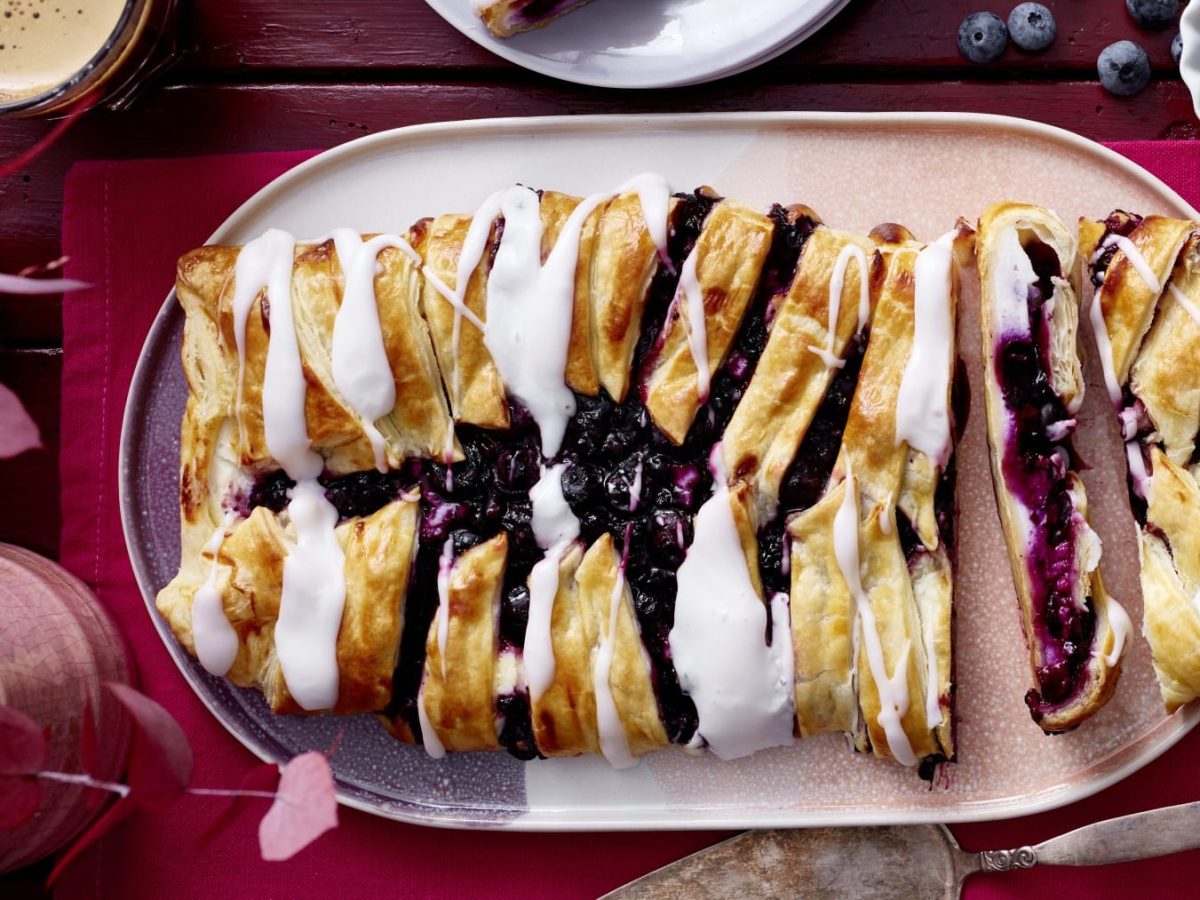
[426,0,850,88]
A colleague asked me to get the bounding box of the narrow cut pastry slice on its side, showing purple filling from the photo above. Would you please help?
[977,202,1129,732]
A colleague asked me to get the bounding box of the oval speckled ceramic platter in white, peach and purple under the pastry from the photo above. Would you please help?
[121,113,1200,829]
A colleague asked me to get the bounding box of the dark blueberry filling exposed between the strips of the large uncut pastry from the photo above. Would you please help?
[245,194,825,758]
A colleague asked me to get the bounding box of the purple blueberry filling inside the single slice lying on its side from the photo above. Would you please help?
[995,240,1096,720]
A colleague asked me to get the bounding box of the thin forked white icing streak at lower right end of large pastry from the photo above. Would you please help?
[833,457,917,766]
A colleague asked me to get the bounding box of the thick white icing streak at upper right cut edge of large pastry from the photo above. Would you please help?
[895,232,956,466]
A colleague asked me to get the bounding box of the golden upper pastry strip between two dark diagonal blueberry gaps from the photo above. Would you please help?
[646,200,775,444]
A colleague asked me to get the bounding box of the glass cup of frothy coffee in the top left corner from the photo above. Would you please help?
[0,0,176,115]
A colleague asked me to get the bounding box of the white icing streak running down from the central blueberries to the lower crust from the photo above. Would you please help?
[523,463,580,701]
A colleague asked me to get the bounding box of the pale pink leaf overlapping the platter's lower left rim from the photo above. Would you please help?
[258,750,337,862]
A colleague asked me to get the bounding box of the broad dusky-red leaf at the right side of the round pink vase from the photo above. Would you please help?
[104,682,193,812]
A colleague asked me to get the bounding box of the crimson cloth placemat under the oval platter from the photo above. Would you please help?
[58,142,1200,900]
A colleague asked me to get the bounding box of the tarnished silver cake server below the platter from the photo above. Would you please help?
[601,802,1200,900]
